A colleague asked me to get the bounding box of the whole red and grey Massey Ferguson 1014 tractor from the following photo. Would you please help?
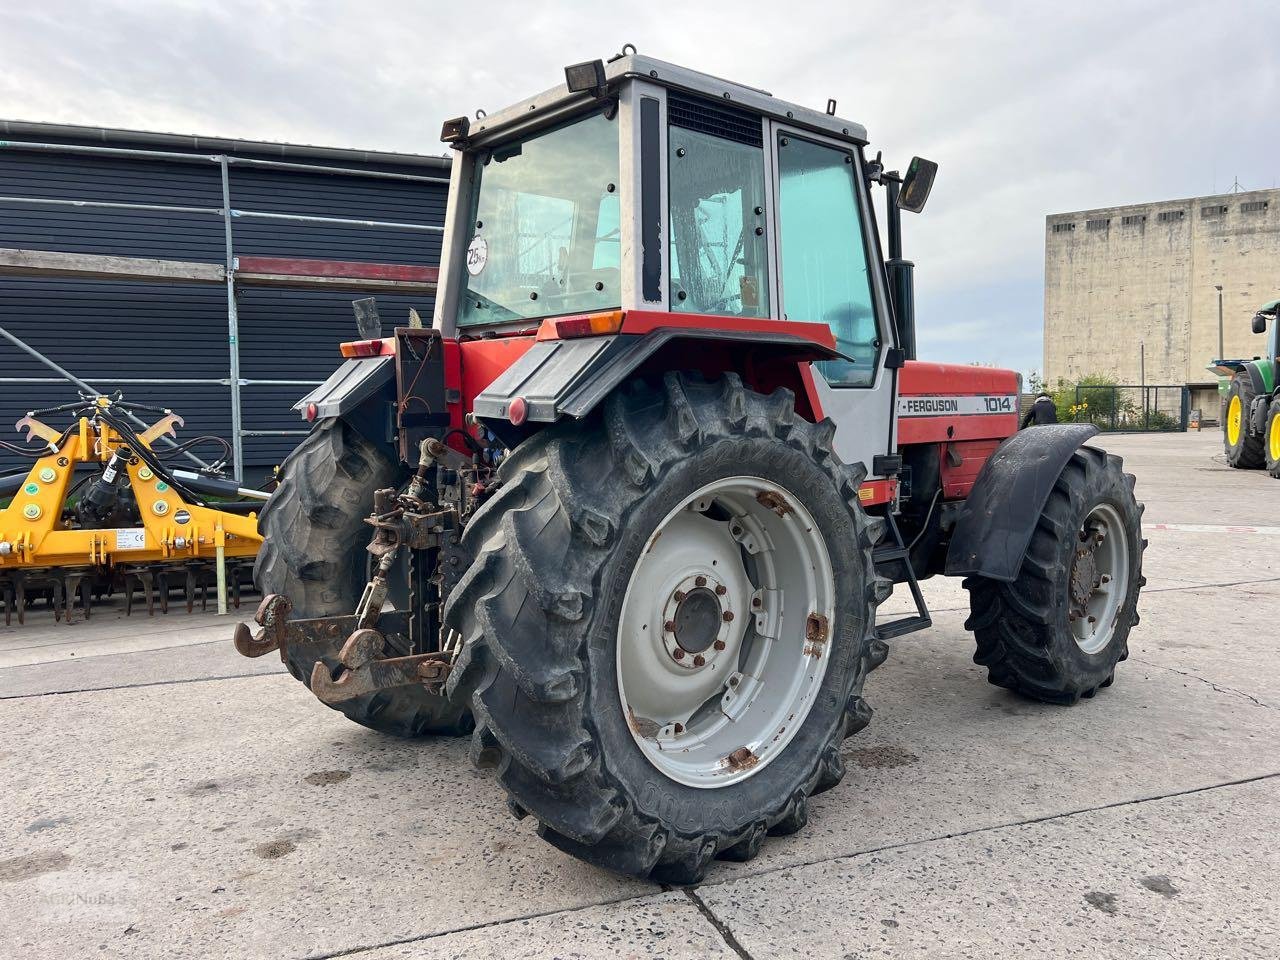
[236,50,1144,883]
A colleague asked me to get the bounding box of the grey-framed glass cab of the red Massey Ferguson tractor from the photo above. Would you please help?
[434,54,936,468]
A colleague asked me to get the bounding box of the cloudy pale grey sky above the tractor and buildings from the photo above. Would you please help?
[0,0,1280,372]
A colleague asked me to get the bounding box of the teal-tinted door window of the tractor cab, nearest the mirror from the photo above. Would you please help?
[778,134,879,387]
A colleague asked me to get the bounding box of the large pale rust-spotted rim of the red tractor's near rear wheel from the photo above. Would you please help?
[617,476,835,788]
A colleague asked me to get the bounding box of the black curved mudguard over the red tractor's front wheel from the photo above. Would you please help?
[946,424,1098,582]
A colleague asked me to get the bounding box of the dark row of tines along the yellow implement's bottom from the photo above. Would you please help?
[0,557,253,626]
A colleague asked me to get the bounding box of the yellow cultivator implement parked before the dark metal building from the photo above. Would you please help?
[0,396,268,625]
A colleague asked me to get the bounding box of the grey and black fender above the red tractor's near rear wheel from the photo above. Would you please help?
[472,328,844,424]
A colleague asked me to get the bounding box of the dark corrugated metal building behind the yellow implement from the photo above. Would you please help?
[0,120,448,477]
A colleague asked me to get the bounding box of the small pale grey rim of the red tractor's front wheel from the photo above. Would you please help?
[1068,503,1129,654]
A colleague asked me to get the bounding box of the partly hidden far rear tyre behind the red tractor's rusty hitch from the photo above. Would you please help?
[253,420,471,737]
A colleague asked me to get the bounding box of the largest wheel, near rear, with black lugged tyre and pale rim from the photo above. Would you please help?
[445,374,890,883]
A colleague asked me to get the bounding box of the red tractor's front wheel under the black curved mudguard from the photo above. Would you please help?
[964,447,1147,704]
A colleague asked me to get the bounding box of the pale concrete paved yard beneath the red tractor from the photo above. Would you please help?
[0,433,1280,960]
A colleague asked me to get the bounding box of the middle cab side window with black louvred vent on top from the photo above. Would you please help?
[667,99,769,317]
